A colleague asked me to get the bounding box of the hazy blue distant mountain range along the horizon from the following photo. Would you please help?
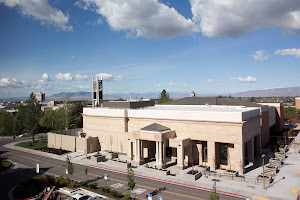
[0,87,300,101]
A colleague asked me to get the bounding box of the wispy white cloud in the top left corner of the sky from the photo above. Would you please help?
[0,0,73,31]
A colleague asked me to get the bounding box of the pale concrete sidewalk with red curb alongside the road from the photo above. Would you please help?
[5,141,300,200]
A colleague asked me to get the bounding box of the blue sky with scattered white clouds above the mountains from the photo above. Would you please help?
[0,0,300,97]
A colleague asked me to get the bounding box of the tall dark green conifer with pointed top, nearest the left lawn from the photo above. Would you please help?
[24,93,41,142]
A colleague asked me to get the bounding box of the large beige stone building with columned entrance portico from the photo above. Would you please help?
[79,97,283,173]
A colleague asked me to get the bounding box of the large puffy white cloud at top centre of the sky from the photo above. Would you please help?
[75,0,197,39]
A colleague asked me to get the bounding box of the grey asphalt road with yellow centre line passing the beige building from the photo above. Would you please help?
[0,139,244,200]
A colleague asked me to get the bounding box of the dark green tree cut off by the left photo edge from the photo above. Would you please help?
[0,112,14,136]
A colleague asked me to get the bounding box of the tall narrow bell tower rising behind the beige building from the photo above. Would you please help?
[92,76,103,107]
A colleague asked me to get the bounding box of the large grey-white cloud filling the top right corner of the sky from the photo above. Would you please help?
[190,0,300,37]
